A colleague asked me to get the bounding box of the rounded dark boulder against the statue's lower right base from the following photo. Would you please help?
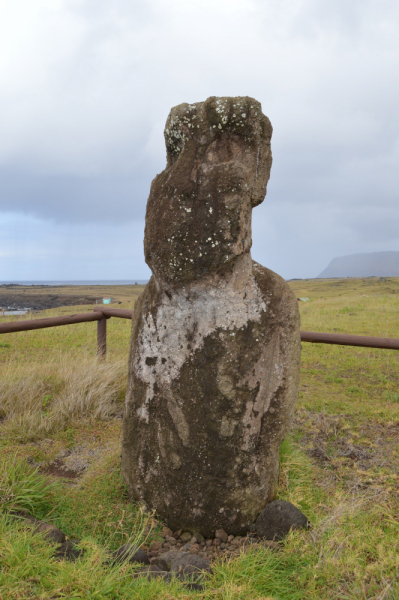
[256,500,309,540]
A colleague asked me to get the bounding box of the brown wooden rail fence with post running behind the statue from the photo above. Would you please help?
[0,307,399,358]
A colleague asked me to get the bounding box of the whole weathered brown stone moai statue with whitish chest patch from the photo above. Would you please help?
[122,97,300,537]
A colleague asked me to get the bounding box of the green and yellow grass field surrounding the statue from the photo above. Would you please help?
[0,278,399,600]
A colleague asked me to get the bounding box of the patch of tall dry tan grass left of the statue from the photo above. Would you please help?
[0,352,127,442]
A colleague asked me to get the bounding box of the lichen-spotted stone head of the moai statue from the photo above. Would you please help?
[145,97,272,285]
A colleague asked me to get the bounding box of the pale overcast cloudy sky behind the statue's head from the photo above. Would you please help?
[0,0,399,280]
